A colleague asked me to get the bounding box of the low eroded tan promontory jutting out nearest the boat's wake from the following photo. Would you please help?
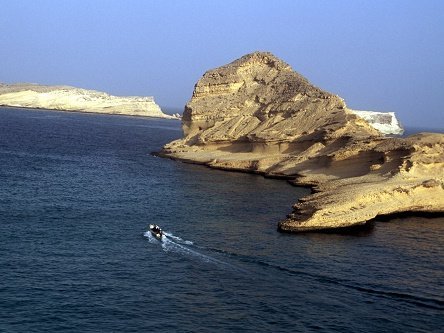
[279,133,444,231]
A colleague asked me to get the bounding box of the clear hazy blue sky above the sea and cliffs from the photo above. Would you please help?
[0,0,444,129]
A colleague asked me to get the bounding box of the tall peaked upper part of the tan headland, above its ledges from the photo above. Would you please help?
[183,52,379,145]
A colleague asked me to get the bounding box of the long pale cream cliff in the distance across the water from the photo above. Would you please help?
[0,83,177,119]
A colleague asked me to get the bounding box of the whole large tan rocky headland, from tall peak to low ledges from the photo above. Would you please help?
[159,52,444,232]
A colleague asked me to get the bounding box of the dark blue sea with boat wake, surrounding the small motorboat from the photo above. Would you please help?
[0,109,444,332]
